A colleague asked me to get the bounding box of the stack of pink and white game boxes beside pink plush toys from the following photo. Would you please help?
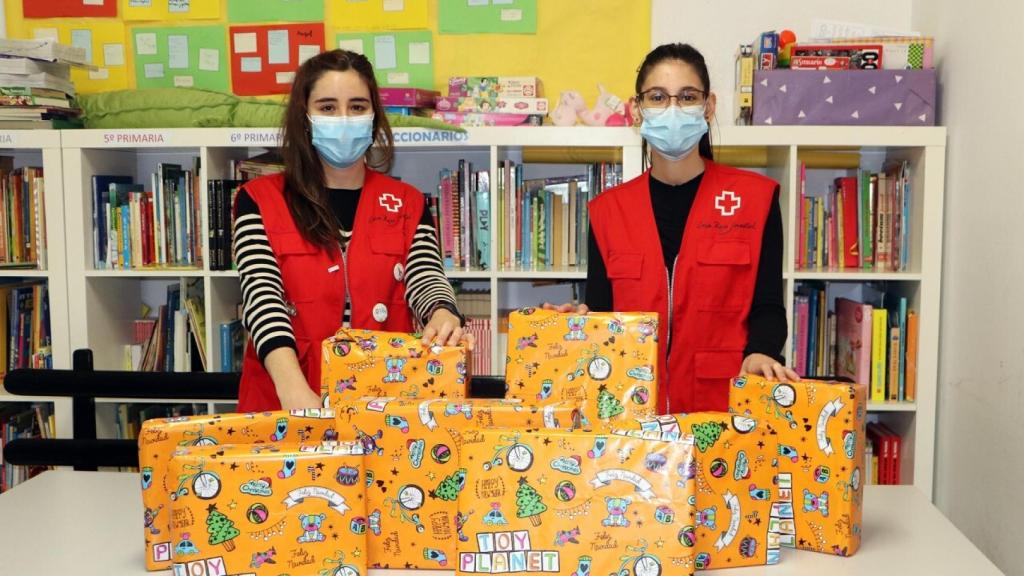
[433,76,548,126]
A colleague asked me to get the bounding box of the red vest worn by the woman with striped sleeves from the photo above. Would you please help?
[239,168,424,412]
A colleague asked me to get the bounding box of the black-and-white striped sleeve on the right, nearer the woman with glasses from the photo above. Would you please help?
[406,205,459,324]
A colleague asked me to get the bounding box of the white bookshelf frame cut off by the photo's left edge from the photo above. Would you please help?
[0,130,72,438]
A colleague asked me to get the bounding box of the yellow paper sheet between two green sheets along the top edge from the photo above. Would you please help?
[327,0,430,32]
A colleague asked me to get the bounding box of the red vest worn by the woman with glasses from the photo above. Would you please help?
[590,160,777,414]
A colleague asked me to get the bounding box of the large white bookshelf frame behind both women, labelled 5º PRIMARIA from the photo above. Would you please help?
[56,126,946,495]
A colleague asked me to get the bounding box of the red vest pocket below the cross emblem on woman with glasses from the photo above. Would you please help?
[695,240,755,305]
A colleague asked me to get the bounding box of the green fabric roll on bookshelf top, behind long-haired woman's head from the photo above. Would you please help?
[78,88,465,132]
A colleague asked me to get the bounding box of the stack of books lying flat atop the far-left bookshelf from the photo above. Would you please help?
[0,39,88,130]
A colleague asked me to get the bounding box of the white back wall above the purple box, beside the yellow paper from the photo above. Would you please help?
[647,0,911,126]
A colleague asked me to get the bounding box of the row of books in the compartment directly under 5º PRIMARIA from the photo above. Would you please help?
[92,160,203,270]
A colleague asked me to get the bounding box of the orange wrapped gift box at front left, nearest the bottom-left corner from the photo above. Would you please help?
[168,443,367,576]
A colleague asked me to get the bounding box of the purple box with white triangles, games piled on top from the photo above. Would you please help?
[735,30,936,126]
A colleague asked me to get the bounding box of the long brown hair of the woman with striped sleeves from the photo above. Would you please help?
[282,50,394,250]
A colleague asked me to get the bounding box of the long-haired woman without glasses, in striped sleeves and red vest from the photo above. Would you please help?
[233,50,472,412]
